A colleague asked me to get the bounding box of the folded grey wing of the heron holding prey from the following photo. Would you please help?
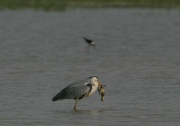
[52,78,92,101]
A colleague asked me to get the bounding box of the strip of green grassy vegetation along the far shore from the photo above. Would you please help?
[0,0,180,10]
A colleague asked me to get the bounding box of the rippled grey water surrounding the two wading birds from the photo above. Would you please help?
[0,9,180,126]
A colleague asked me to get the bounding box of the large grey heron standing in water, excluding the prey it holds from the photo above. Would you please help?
[52,76,103,110]
